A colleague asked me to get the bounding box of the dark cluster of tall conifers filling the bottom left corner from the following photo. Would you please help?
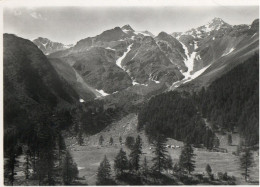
[4,107,78,185]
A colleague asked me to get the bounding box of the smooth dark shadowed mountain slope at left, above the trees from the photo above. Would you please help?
[4,34,79,125]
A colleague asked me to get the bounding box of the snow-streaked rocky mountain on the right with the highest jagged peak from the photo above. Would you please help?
[171,19,259,90]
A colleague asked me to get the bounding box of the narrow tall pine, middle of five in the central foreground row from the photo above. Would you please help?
[129,135,142,172]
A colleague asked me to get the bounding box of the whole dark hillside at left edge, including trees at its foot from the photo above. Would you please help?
[4,34,79,185]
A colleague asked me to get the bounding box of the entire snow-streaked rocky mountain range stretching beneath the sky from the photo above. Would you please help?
[4,18,259,106]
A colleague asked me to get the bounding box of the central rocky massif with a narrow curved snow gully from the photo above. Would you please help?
[49,25,185,94]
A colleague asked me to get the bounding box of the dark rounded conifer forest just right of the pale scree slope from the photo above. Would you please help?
[138,92,216,149]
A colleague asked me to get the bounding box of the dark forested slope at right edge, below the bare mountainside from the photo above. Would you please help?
[195,54,259,145]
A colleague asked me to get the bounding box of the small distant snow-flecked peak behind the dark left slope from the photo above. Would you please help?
[33,37,73,55]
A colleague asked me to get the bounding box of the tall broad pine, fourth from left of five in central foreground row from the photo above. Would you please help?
[152,135,168,173]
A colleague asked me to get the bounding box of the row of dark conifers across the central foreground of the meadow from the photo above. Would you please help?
[96,135,195,185]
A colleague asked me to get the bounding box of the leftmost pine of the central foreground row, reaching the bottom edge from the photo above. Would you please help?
[96,155,111,185]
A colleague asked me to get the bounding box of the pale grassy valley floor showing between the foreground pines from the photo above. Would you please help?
[66,114,259,185]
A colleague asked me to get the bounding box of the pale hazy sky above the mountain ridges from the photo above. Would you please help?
[4,6,259,44]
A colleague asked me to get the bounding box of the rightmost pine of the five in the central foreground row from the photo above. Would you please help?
[179,144,195,174]
